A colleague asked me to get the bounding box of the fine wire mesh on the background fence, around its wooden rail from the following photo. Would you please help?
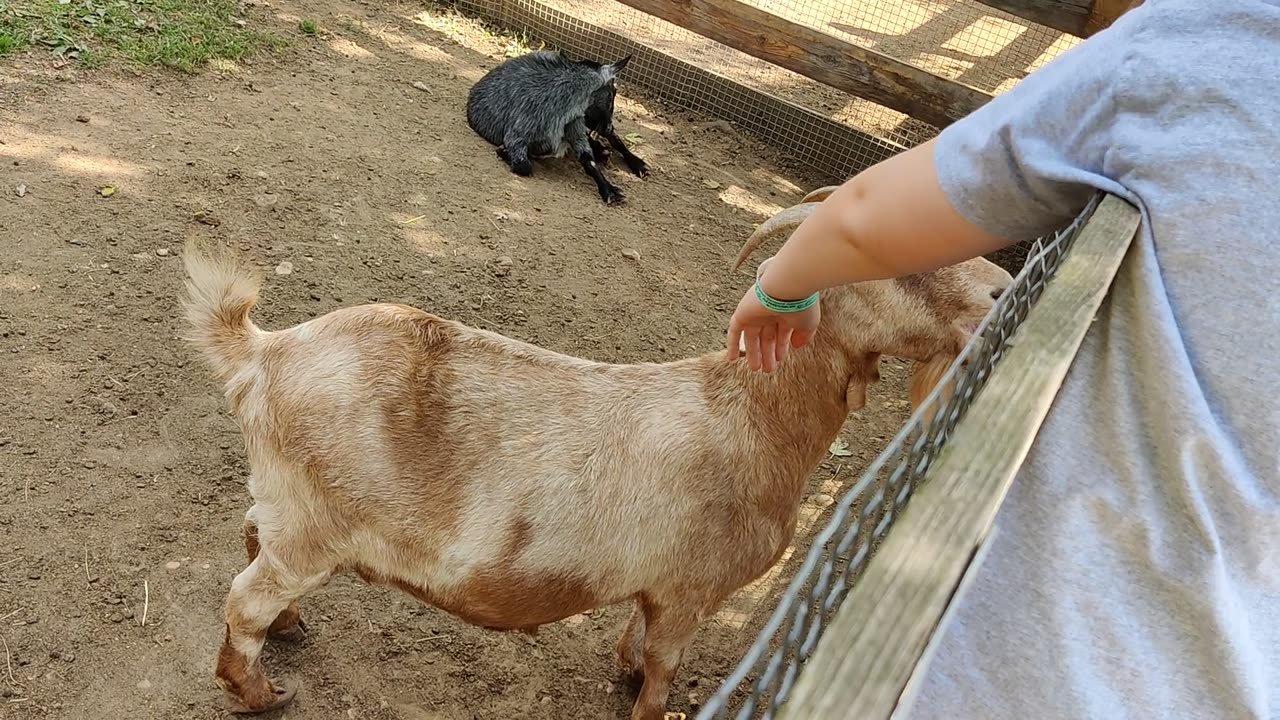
[448,0,1079,181]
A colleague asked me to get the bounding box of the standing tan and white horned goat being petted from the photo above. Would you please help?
[184,198,1009,720]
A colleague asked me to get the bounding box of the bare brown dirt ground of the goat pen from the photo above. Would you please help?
[0,0,921,720]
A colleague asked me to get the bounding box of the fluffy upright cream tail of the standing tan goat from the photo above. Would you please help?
[182,241,262,380]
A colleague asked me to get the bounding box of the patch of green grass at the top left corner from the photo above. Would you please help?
[0,0,284,72]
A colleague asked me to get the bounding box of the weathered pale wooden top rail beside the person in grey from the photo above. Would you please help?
[778,196,1139,720]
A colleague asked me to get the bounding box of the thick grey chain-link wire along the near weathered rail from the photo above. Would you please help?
[696,195,1103,720]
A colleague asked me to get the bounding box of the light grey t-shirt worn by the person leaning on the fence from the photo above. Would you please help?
[908,0,1280,720]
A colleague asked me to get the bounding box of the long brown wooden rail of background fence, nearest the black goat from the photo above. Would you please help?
[606,0,991,128]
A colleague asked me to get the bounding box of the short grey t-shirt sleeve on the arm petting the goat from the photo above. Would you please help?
[934,8,1142,242]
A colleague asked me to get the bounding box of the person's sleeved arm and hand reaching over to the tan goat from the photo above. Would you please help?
[727,0,1156,372]
